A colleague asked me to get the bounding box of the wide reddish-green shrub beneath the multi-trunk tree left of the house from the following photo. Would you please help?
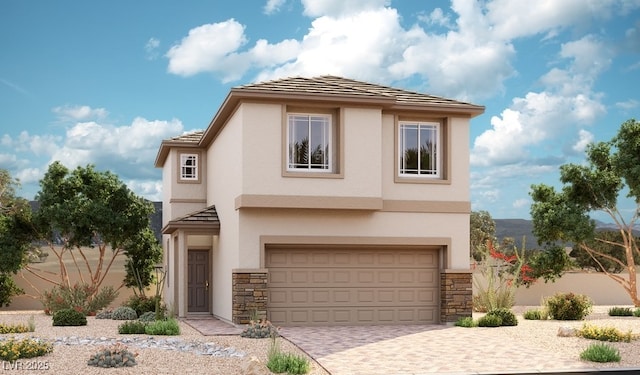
[41,283,118,315]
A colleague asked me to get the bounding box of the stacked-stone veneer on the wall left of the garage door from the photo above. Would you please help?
[231,270,267,324]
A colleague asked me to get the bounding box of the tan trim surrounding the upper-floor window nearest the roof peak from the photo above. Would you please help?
[281,104,344,178]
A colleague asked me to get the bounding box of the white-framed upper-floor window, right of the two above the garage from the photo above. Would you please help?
[398,122,442,178]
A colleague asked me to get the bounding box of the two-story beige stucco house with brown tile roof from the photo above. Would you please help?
[155,76,484,325]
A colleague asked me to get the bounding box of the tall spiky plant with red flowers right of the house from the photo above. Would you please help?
[473,240,536,311]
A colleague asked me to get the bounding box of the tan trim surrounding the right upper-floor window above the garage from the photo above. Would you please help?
[394,117,451,184]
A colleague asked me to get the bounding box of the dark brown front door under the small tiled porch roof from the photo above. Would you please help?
[187,250,209,312]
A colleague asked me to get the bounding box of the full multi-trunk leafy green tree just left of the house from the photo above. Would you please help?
[25,162,162,304]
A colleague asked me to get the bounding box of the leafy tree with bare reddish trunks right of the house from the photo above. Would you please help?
[531,119,640,306]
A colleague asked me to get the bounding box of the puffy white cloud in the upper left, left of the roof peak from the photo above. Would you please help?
[166,19,247,77]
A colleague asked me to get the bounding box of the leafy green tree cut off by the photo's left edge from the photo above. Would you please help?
[0,169,33,306]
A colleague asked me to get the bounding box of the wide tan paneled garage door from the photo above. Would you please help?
[266,245,439,326]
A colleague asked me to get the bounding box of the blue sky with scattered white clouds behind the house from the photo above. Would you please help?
[0,0,640,218]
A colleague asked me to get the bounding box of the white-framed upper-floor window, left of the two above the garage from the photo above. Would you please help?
[287,114,334,172]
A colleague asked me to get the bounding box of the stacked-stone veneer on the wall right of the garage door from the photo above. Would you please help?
[440,271,473,323]
